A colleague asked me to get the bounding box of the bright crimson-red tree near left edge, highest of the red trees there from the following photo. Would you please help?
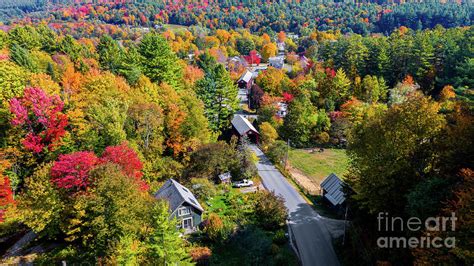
[10,88,68,153]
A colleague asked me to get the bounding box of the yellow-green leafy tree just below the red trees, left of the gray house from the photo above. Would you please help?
[78,164,152,257]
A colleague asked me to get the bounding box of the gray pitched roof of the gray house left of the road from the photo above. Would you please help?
[155,179,204,212]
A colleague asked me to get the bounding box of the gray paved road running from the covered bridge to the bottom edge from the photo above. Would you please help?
[250,145,339,266]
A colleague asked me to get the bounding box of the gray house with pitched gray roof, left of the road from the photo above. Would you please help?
[155,179,204,233]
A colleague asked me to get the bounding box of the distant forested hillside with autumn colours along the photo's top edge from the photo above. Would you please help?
[0,0,474,35]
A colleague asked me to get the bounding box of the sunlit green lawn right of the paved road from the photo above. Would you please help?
[289,149,349,184]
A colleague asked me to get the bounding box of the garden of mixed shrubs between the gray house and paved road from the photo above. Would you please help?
[188,180,298,265]
